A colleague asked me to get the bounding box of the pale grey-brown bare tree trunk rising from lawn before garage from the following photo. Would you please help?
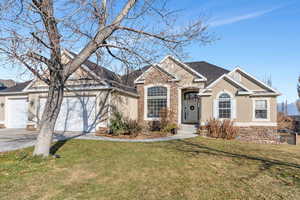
[33,82,64,157]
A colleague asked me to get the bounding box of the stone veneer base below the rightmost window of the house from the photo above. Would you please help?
[237,126,280,144]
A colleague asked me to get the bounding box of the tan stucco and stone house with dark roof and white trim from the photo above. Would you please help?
[0,50,280,136]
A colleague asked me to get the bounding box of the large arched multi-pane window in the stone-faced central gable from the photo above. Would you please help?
[147,86,167,118]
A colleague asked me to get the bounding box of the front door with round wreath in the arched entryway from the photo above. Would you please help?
[182,92,199,124]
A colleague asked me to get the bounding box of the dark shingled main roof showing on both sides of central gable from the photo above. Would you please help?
[121,61,230,86]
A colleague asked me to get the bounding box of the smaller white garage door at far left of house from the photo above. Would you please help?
[6,98,28,128]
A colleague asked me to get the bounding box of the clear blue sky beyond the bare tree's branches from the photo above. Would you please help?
[0,0,300,102]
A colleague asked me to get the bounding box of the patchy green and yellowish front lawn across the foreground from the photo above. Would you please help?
[0,137,300,200]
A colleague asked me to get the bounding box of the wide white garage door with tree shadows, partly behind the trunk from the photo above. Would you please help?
[40,97,96,132]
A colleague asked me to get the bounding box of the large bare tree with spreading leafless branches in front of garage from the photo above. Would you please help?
[0,0,211,156]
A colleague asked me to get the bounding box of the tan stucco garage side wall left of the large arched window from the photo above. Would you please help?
[112,92,138,120]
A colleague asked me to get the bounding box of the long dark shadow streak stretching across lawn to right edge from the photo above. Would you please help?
[166,140,300,169]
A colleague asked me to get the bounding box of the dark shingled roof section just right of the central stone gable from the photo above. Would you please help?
[185,61,229,85]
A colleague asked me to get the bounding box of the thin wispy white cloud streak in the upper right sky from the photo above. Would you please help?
[209,6,282,27]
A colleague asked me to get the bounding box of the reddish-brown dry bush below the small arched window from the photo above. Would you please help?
[206,119,239,140]
